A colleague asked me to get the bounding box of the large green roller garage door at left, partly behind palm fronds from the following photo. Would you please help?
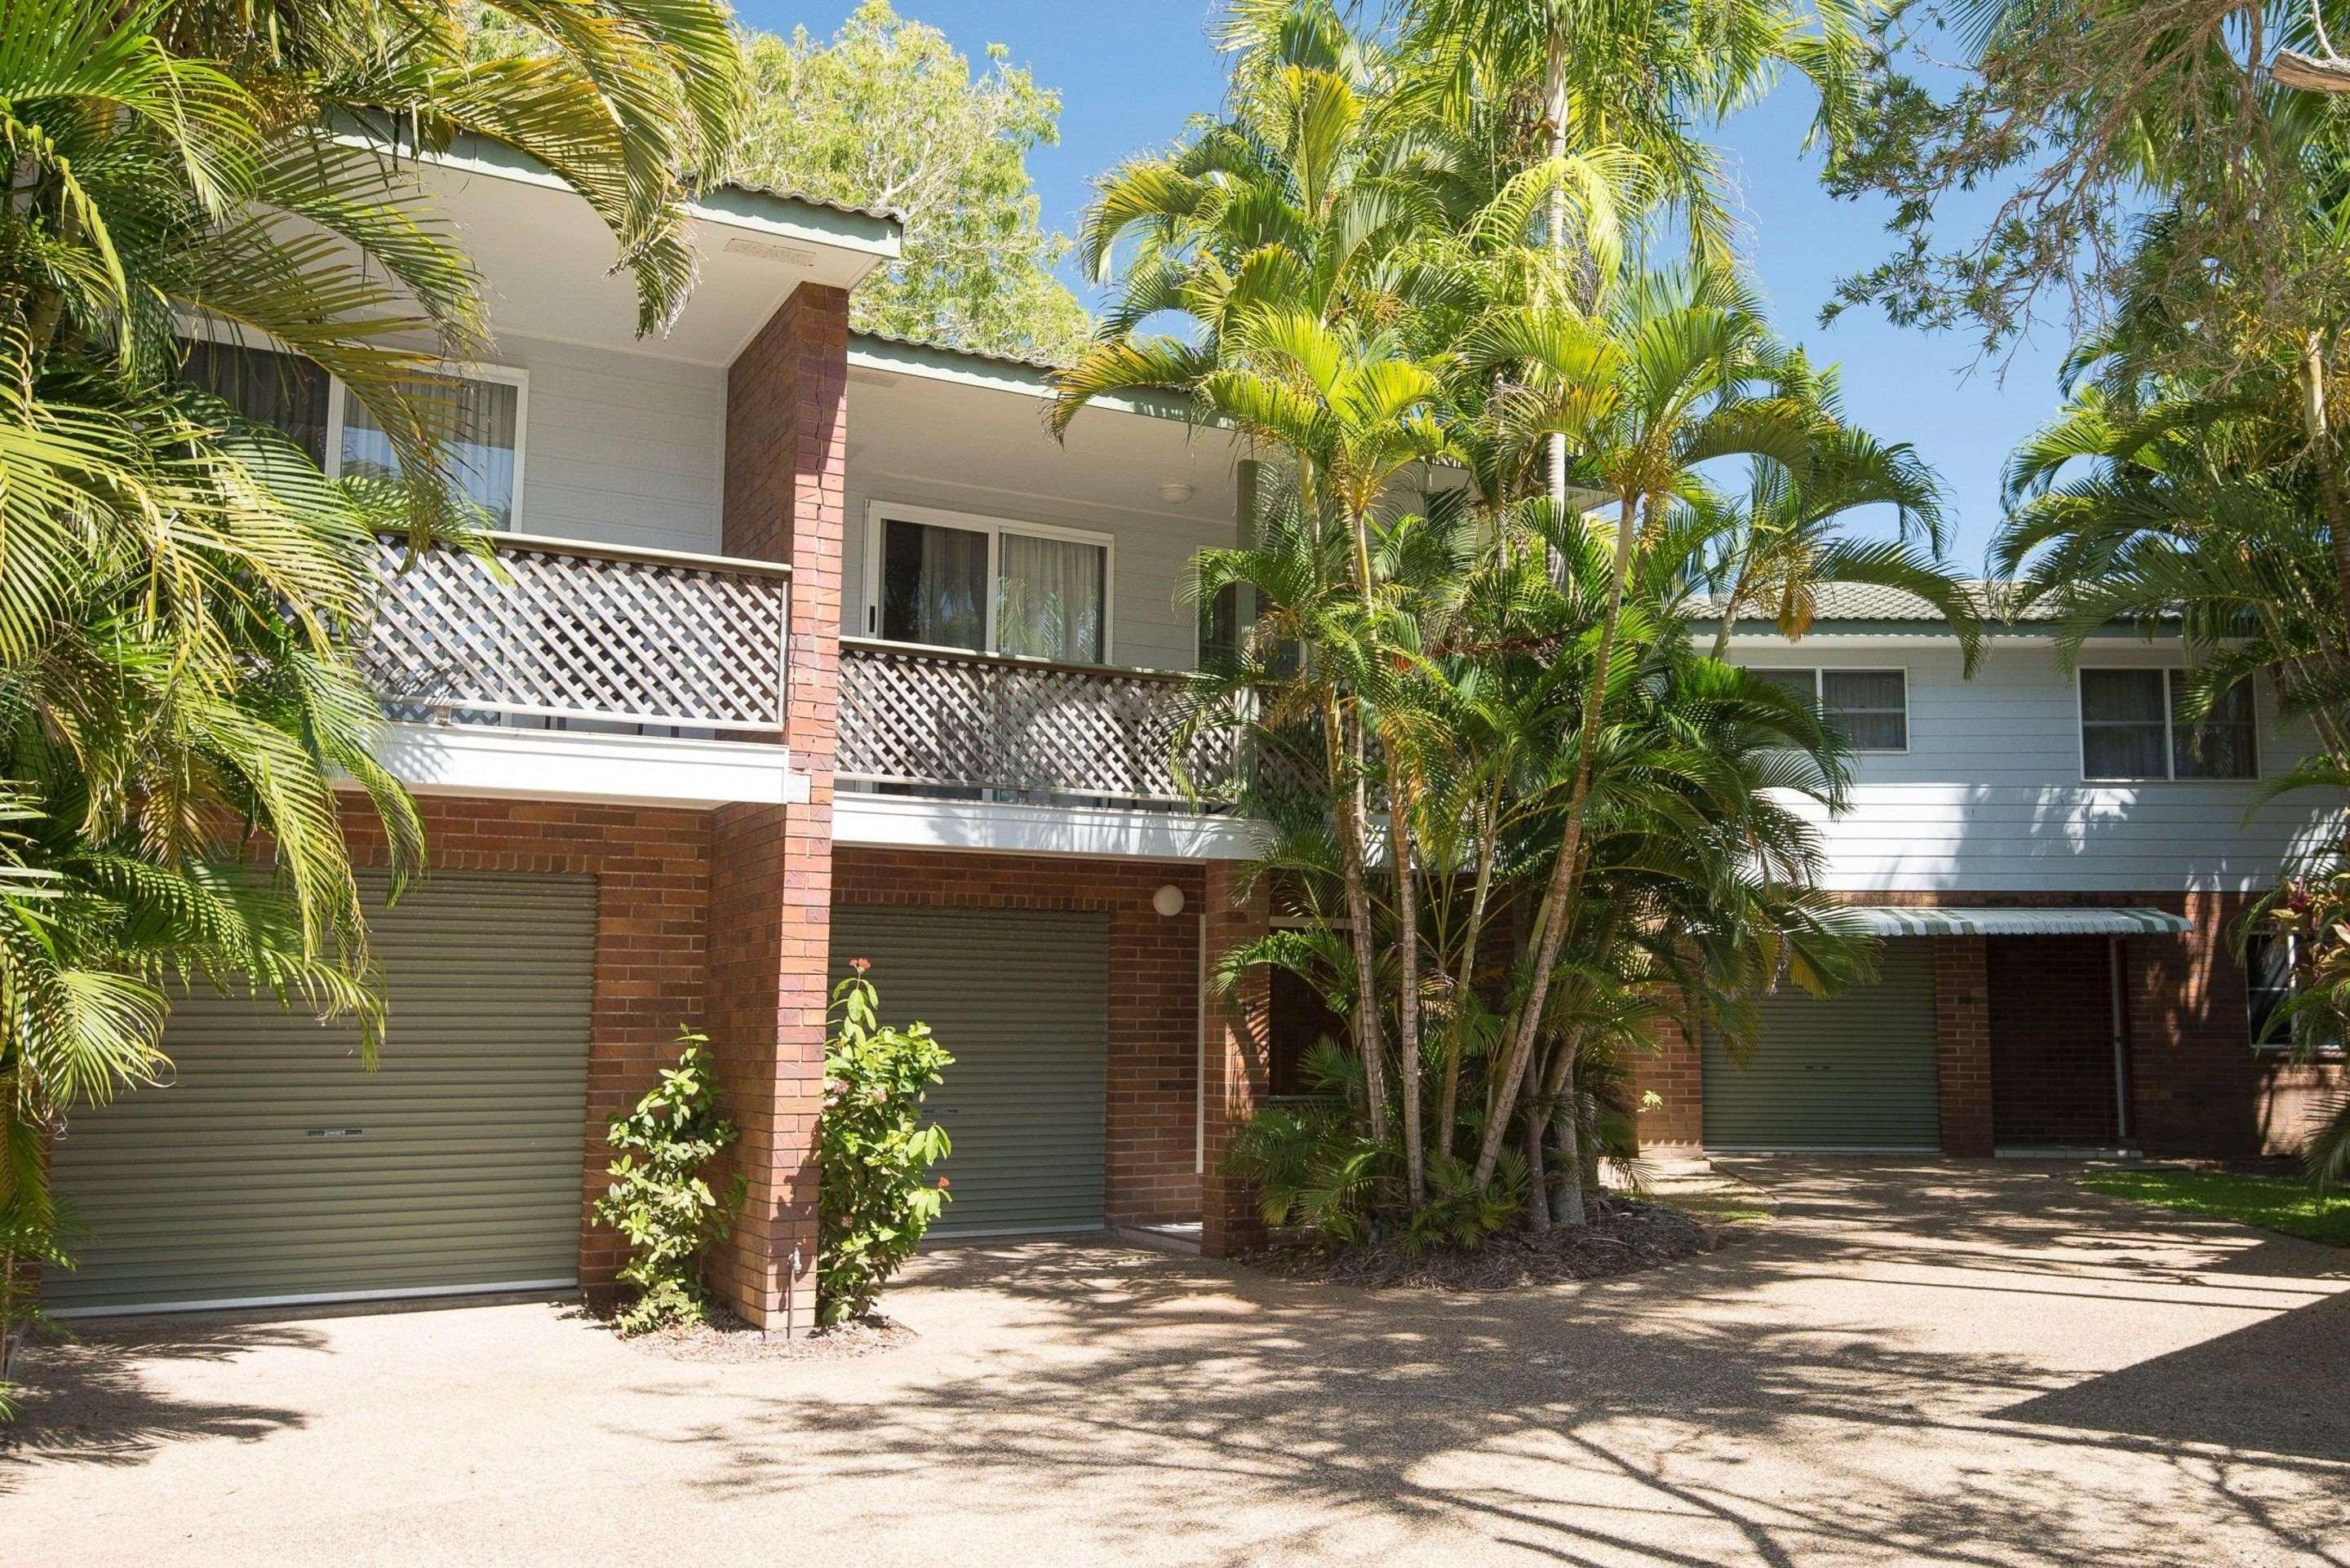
[47,875,595,1312]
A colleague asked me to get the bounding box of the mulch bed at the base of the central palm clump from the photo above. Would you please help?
[1248,1194,1734,1291]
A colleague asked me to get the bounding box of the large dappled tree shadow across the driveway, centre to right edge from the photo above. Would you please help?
[625,1168,2350,1568]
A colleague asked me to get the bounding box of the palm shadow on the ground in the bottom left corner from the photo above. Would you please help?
[0,1323,326,1493]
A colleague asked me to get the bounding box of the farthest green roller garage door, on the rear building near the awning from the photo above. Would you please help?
[1704,941,1939,1149]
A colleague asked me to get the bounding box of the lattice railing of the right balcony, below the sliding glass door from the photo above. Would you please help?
[836,637,1234,806]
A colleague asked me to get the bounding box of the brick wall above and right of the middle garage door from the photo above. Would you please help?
[832,848,1215,1225]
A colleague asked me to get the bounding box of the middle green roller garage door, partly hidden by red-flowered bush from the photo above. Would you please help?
[832,905,1109,1237]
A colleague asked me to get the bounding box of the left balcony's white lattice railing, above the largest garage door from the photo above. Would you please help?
[366,534,790,731]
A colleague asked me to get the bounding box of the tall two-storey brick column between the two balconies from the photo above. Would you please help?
[710,285,849,1331]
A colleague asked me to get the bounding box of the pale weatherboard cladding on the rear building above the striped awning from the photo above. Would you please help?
[1730,632,2329,893]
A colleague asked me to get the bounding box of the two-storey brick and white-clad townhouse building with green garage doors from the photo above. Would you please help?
[49,153,2329,1328]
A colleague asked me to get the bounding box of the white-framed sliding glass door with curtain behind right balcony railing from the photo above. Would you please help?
[871,512,1109,665]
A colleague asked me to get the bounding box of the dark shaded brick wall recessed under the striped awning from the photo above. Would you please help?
[1988,936,2120,1149]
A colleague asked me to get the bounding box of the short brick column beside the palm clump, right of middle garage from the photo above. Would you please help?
[1199,861,1274,1258]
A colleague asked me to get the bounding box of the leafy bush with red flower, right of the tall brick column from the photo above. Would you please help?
[815,959,954,1326]
